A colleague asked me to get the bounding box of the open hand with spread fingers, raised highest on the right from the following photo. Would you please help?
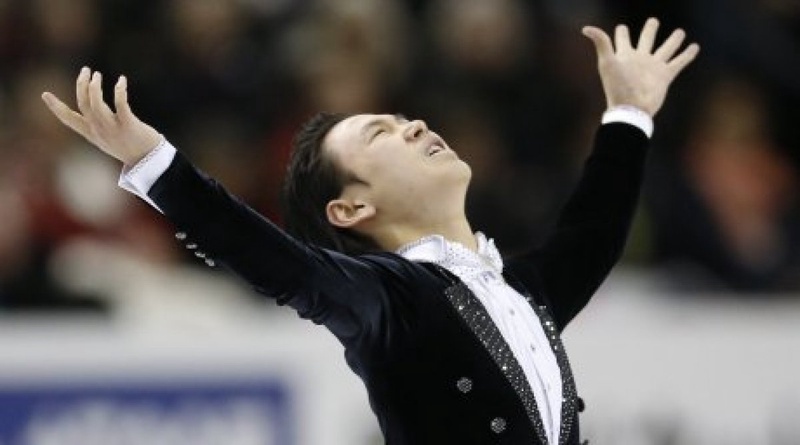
[583,18,700,116]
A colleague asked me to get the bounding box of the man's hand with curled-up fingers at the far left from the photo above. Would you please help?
[42,67,163,166]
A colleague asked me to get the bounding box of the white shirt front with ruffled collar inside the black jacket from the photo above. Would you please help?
[397,232,562,444]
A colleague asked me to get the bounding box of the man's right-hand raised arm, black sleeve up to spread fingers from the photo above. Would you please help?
[510,18,699,328]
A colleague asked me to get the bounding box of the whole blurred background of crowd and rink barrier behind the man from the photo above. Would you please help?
[0,0,800,445]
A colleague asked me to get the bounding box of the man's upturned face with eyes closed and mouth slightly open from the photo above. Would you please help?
[325,114,471,227]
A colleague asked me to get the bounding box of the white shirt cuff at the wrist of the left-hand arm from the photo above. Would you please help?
[117,139,177,213]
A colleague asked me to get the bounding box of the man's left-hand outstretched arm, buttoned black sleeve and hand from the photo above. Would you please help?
[42,68,396,337]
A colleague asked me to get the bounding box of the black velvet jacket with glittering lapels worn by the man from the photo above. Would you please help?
[149,123,647,445]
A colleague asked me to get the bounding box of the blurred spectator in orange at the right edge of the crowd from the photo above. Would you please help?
[653,78,800,292]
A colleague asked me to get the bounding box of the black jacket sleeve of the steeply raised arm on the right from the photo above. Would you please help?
[509,123,649,329]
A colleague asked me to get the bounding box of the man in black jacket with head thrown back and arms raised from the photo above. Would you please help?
[43,19,699,445]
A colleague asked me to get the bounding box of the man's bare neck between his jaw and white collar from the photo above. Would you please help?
[375,216,478,252]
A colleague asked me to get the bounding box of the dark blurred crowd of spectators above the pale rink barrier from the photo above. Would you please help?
[0,0,800,312]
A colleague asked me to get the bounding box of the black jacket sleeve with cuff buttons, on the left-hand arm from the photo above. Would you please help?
[148,153,416,340]
